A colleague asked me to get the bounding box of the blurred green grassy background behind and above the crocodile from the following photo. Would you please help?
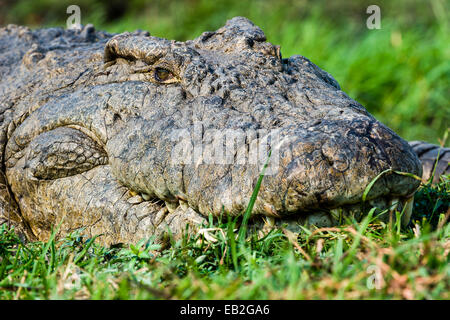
[0,0,450,143]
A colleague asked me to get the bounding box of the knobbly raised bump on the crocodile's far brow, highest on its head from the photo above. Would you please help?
[194,17,281,59]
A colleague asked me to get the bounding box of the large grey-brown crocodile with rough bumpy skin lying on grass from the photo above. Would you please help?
[0,17,422,244]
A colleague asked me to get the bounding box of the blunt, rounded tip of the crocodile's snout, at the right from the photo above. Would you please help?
[273,116,421,212]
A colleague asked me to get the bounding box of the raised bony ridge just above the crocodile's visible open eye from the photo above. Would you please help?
[103,32,170,65]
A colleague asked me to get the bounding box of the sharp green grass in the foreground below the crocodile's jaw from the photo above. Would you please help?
[0,177,450,299]
